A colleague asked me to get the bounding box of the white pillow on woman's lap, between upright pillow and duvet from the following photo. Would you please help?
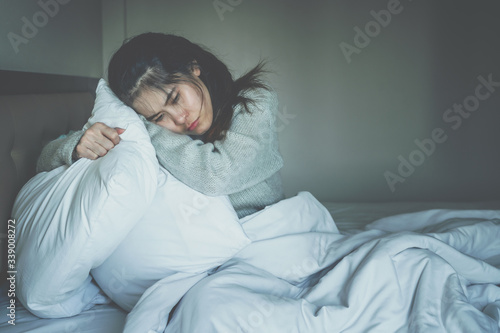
[92,167,250,311]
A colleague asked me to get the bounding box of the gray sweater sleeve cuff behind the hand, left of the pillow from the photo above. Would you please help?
[36,130,84,173]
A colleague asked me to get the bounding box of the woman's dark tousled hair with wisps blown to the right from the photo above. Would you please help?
[108,32,269,142]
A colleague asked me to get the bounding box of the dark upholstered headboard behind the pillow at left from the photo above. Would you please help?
[0,70,98,280]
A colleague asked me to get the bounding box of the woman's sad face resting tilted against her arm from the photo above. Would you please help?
[132,67,213,135]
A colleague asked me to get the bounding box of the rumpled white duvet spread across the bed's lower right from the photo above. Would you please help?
[125,193,500,333]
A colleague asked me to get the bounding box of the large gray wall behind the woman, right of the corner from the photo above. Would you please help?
[103,0,500,201]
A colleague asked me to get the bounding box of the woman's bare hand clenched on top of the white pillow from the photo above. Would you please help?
[73,123,125,161]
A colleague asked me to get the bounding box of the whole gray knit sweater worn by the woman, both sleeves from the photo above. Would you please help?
[37,89,284,218]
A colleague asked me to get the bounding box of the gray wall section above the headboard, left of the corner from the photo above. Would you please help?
[0,0,102,77]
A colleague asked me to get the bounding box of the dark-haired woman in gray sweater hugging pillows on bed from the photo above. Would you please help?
[37,33,284,218]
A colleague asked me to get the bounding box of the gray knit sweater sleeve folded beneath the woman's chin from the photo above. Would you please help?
[145,89,283,195]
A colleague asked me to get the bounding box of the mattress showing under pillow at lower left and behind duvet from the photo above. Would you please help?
[0,201,500,333]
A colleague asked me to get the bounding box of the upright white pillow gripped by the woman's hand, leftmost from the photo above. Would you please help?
[12,80,159,318]
